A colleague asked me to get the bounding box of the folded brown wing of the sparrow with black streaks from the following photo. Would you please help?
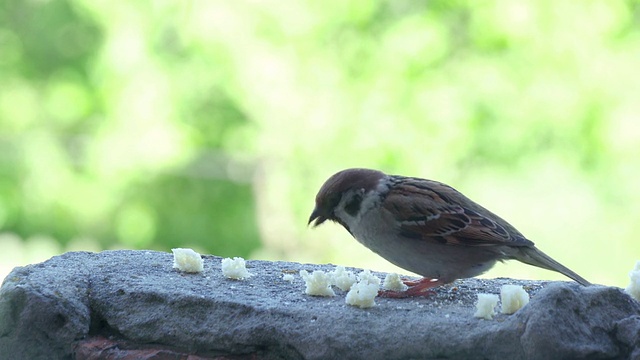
[382,178,533,246]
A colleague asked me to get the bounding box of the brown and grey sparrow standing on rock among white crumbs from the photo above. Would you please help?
[308,169,591,297]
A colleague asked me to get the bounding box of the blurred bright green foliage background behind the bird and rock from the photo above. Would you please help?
[0,0,640,286]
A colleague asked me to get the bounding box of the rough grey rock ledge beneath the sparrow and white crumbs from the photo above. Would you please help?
[0,251,640,359]
